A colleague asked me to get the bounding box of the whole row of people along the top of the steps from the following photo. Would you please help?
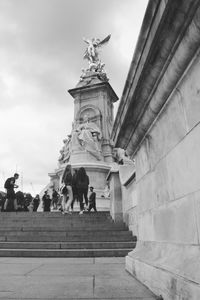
[0,168,97,214]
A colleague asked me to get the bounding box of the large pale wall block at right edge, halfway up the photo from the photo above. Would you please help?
[166,125,200,200]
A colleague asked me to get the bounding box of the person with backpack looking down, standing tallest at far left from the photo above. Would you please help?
[4,173,19,211]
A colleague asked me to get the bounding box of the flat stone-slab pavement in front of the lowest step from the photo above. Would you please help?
[0,257,156,300]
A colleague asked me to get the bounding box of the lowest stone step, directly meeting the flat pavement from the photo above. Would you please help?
[0,248,132,257]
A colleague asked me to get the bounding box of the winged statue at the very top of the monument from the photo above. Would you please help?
[83,34,111,64]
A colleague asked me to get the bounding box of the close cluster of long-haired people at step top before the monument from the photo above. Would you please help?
[60,164,97,214]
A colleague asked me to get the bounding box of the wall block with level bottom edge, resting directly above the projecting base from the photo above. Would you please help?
[139,195,198,244]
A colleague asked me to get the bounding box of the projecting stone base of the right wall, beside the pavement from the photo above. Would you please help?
[126,242,200,300]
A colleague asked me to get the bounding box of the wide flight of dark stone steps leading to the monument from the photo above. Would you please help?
[0,212,136,257]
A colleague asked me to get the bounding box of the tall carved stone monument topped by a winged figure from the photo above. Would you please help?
[49,35,118,210]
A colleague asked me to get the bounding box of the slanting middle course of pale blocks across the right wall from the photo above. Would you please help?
[133,122,200,212]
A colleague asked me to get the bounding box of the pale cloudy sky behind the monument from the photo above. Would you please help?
[0,0,148,195]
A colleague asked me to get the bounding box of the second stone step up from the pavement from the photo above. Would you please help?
[0,241,136,249]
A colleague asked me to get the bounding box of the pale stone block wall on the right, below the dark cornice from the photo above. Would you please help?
[126,53,200,299]
